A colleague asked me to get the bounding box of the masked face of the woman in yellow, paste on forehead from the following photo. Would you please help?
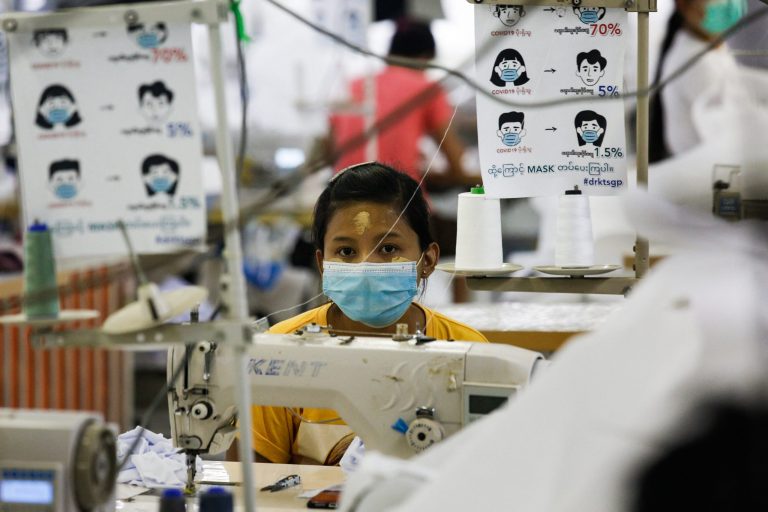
[316,202,439,329]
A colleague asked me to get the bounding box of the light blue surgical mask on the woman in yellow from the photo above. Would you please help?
[323,261,417,328]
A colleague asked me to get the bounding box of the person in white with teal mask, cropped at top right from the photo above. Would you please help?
[650,0,747,163]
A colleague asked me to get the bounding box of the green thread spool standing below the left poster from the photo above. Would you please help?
[24,222,59,318]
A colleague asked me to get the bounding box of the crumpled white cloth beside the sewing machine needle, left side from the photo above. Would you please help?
[117,427,203,488]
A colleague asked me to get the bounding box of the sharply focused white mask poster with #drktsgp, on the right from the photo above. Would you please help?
[475,4,627,198]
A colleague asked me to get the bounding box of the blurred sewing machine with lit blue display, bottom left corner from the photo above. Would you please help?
[0,409,117,512]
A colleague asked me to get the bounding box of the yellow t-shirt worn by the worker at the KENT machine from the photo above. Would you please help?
[252,303,488,464]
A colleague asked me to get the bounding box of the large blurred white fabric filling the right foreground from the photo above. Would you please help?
[342,190,768,512]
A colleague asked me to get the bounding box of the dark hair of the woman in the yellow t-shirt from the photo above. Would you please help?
[312,162,435,252]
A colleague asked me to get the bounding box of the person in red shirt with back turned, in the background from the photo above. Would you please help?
[330,20,480,190]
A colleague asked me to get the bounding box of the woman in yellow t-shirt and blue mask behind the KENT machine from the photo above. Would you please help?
[253,162,487,465]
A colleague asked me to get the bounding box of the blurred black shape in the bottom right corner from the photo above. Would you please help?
[628,398,768,512]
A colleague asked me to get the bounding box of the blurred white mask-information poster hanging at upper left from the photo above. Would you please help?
[8,20,206,258]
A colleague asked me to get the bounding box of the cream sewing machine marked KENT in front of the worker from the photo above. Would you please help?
[168,332,545,490]
